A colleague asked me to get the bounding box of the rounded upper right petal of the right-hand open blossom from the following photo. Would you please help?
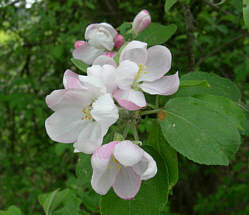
[140,45,172,81]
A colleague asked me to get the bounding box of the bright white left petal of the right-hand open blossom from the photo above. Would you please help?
[116,60,139,90]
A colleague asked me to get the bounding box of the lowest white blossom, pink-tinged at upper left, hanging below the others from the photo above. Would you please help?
[91,140,157,199]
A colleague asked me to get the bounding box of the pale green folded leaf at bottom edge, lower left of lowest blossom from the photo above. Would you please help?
[38,189,70,215]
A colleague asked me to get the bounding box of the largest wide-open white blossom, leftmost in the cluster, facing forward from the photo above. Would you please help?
[45,71,119,154]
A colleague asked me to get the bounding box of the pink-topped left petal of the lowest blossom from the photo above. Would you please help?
[91,141,118,195]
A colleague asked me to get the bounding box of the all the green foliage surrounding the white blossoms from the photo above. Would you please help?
[0,0,249,215]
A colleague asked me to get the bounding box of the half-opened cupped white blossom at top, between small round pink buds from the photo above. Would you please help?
[73,23,117,64]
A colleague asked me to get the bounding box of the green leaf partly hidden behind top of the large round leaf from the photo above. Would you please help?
[174,72,240,102]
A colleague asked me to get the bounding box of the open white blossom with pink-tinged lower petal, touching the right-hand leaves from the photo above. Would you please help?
[113,41,180,110]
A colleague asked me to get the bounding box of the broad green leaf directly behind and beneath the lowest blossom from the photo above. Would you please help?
[100,146,168,215]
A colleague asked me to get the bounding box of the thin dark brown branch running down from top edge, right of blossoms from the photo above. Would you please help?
[182,0,195,71]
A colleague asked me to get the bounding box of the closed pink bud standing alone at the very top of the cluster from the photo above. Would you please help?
[132,10,151,34]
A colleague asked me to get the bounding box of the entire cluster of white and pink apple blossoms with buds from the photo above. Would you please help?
[45,10,179,199]
